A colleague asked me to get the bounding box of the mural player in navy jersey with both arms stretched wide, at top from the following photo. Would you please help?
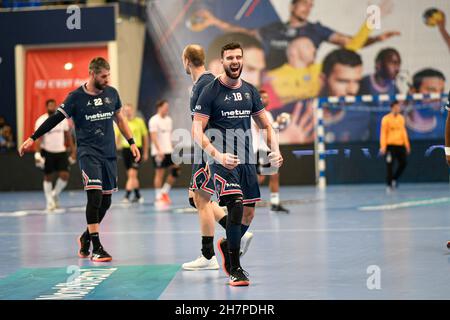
[195,0,400,69]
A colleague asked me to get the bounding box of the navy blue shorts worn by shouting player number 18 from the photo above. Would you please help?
[209,163,261,204]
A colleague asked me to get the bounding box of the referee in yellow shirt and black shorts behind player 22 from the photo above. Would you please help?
[115,103,148,203]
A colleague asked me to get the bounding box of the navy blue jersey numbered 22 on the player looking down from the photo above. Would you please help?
[58,86,122,158]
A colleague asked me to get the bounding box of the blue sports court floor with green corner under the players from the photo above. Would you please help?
[0,184,450,299]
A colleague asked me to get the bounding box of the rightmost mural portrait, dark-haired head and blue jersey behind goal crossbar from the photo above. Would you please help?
[406,68,445,139]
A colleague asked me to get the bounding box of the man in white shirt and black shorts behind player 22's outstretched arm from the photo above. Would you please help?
[34,99,76,211]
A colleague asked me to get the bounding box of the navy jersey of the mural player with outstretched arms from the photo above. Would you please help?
[258,22,335,69]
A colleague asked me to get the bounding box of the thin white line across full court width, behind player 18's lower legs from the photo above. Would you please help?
[0,226,450,237]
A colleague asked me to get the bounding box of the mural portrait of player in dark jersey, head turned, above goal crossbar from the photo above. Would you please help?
[359,48,402,95]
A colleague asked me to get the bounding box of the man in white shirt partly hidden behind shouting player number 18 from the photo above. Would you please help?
[252,90,289,213]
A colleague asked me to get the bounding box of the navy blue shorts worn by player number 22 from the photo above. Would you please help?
[78,156,118,194]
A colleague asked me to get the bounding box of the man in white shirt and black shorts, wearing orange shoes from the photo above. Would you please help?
[148,100,180,204]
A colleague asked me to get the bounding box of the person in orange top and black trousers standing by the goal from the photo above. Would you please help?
[380,101,411,192]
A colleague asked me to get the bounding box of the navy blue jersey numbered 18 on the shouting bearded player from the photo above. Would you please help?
[195,78,264,163]
